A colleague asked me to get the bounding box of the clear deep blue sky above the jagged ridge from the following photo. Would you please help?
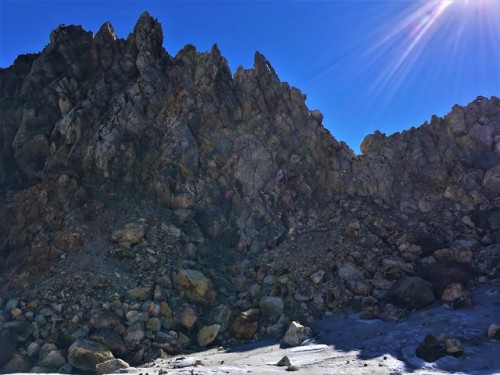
[0,0,500,152]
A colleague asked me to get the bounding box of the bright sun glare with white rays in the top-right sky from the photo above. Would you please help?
[354,0,500,100]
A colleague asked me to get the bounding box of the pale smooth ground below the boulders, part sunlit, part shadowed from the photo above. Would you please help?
[88,285,500,375]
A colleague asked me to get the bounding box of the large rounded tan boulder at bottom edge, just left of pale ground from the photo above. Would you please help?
[68,339,114,372]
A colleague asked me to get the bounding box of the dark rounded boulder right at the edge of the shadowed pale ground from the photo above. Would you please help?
[387,276,434,310]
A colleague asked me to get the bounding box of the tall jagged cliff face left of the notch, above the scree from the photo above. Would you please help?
[0,14,352,256]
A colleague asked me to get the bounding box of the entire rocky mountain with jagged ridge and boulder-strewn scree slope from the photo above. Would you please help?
[0,13,500,372]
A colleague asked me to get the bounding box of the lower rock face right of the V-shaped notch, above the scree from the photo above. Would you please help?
[348,97,500,212]
